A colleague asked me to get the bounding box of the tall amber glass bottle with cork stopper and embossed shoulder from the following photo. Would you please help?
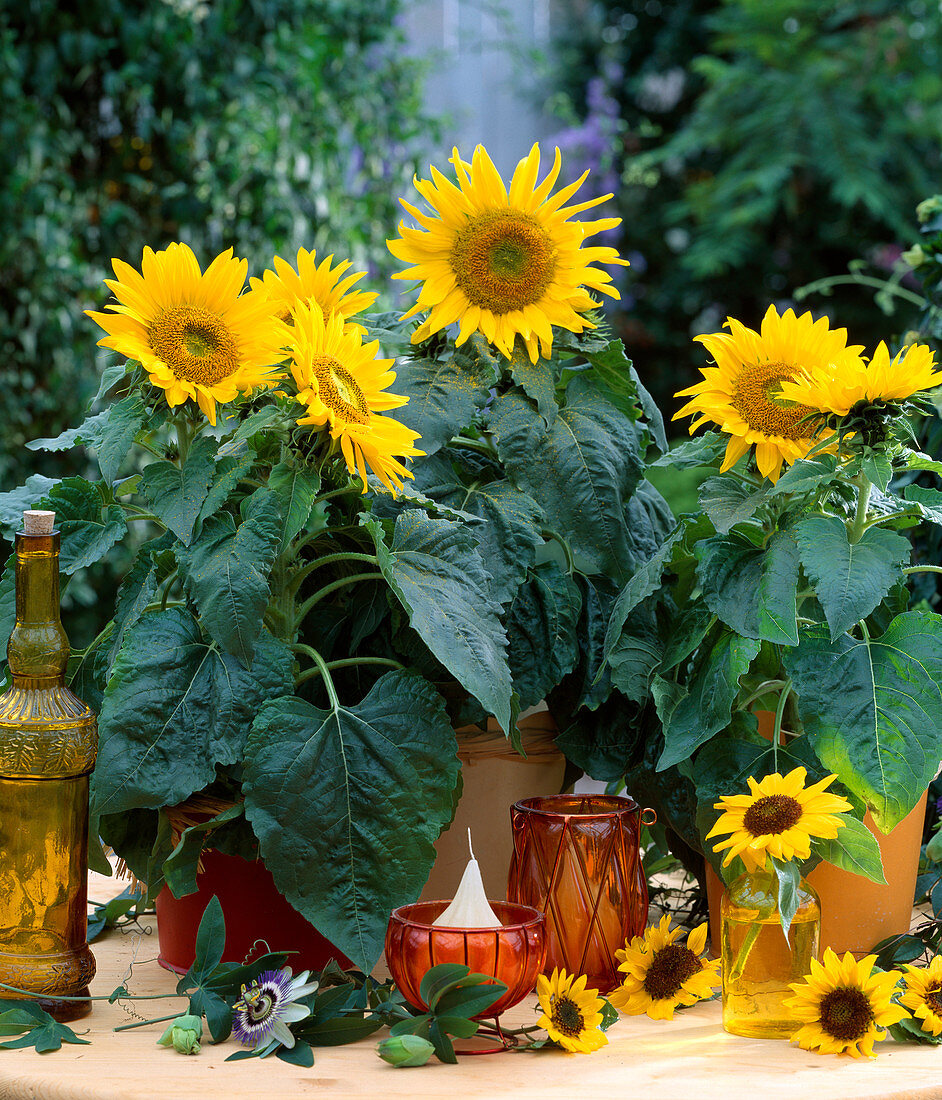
[0,513,98,1021]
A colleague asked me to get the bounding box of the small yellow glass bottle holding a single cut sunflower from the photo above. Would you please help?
[720,871,821,1038]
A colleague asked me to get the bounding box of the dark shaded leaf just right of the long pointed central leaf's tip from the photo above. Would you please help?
[507,562,582,710]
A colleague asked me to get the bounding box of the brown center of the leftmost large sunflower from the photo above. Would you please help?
[147,306,241,386]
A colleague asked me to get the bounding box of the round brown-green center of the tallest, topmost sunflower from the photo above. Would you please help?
[449,210,556,314]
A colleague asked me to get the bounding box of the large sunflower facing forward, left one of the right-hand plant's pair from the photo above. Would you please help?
[673,306,863,482]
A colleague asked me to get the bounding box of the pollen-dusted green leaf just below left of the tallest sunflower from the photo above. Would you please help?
[396,332,501,454]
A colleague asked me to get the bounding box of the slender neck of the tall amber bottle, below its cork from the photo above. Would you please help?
[7,531,69,688]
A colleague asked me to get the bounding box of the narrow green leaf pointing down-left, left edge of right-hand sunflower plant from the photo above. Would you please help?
[657,628,759,771]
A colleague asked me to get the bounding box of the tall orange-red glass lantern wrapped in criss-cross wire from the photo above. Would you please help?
[507,794,657,993]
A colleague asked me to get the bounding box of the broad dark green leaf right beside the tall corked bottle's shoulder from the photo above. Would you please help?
[91,607,293,814]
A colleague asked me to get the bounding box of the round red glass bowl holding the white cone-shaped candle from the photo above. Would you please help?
[386,901,546,1020]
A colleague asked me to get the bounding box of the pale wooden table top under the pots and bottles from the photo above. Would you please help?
[0,877,942,1100]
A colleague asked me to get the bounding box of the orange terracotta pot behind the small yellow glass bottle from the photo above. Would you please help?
[707,794,927,958]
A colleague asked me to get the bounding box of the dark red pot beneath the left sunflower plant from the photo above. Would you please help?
[156,848,353,974]
